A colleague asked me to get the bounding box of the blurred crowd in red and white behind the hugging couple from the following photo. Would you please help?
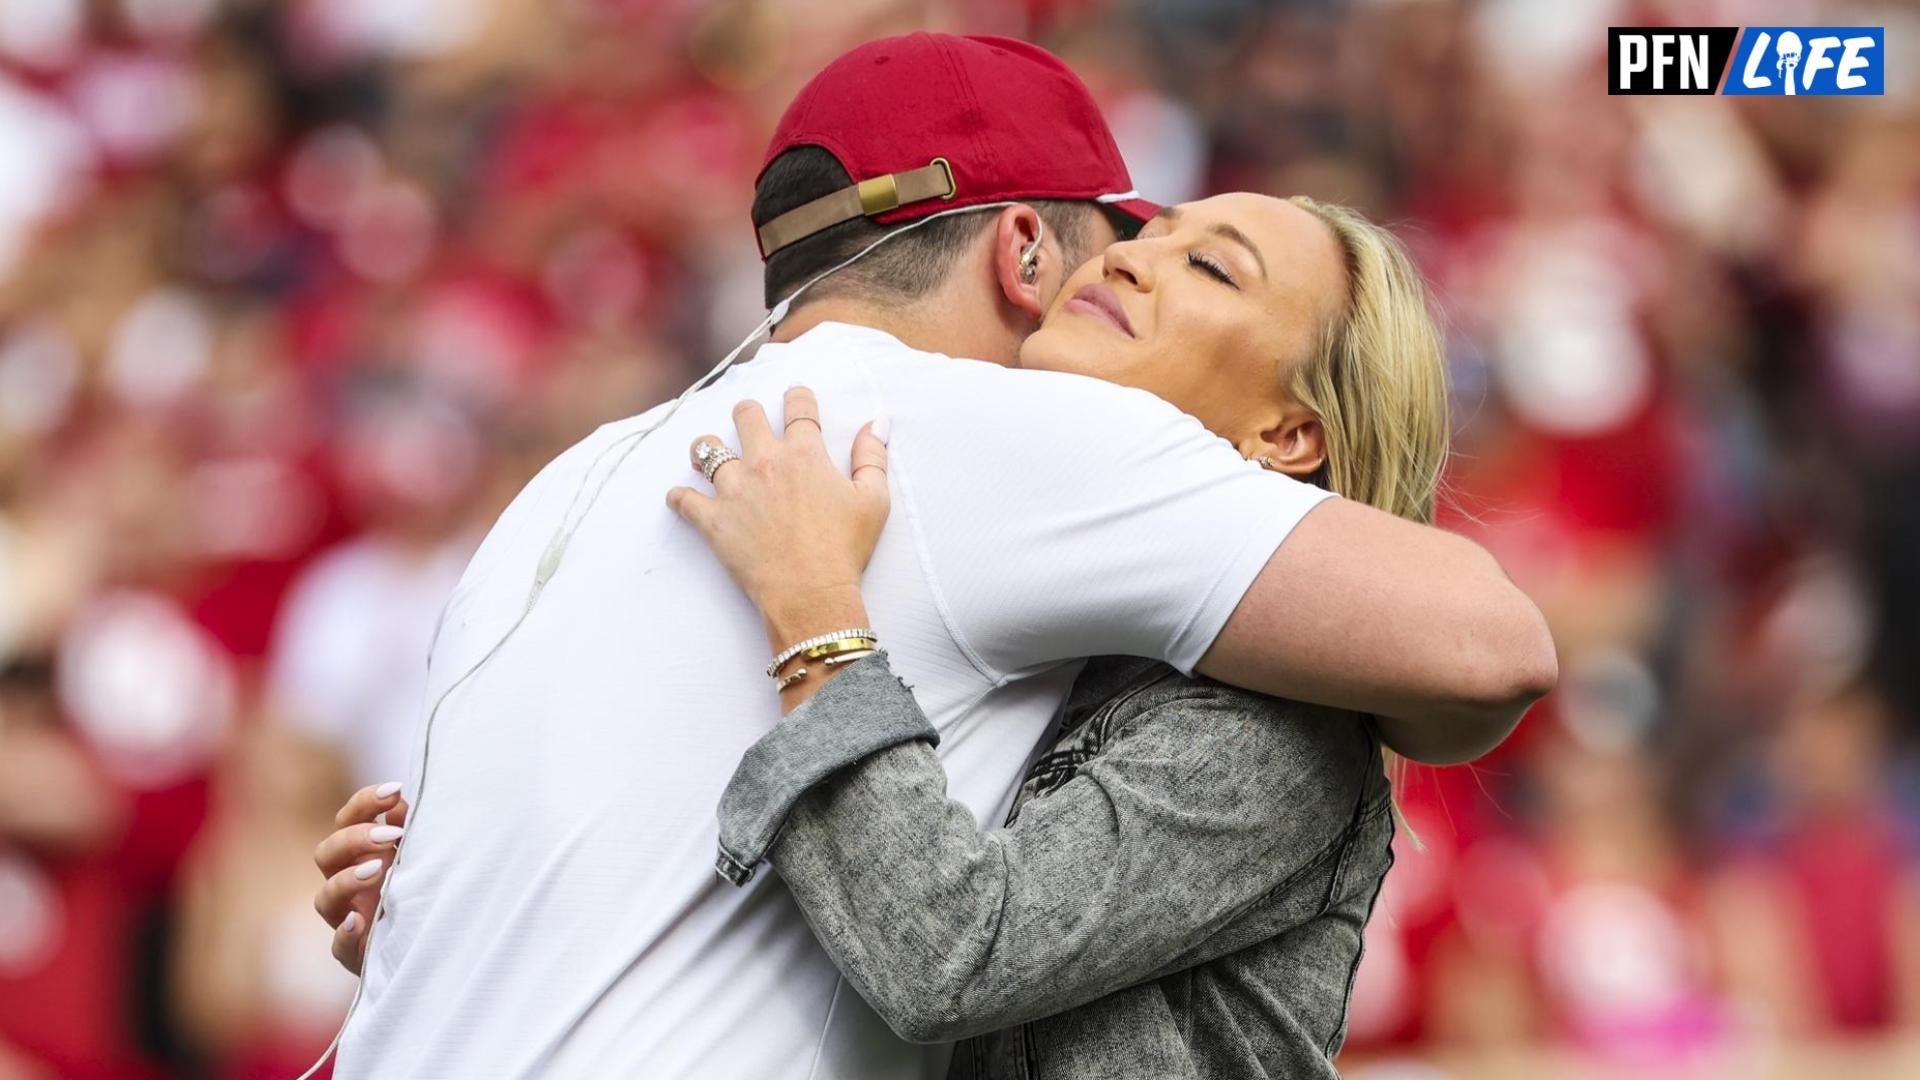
[0,0,1920,1080]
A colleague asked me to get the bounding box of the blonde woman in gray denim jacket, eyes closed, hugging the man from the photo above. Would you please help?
[334,194,1448,1080]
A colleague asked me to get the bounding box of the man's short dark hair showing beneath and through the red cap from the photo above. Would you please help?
[753,146,1100,307]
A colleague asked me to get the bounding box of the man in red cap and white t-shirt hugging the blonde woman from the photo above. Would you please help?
[323,35,1551,1078]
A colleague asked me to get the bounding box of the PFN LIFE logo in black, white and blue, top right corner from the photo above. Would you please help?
[1607,27,1887,96]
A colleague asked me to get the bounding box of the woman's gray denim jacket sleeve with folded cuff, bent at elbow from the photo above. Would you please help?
[706,645,1379,1042]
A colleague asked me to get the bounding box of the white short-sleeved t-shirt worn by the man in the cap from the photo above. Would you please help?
[340,323,1325,1080]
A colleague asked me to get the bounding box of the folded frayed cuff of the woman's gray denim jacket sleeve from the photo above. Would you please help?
[714,653,941,886]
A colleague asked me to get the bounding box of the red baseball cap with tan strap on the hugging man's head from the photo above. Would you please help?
[758,33,1160,258]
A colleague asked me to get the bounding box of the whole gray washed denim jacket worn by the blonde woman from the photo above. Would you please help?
[720,657,1394,1080]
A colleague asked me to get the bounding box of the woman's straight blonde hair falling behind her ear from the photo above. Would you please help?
[1286,196,1452,525]
